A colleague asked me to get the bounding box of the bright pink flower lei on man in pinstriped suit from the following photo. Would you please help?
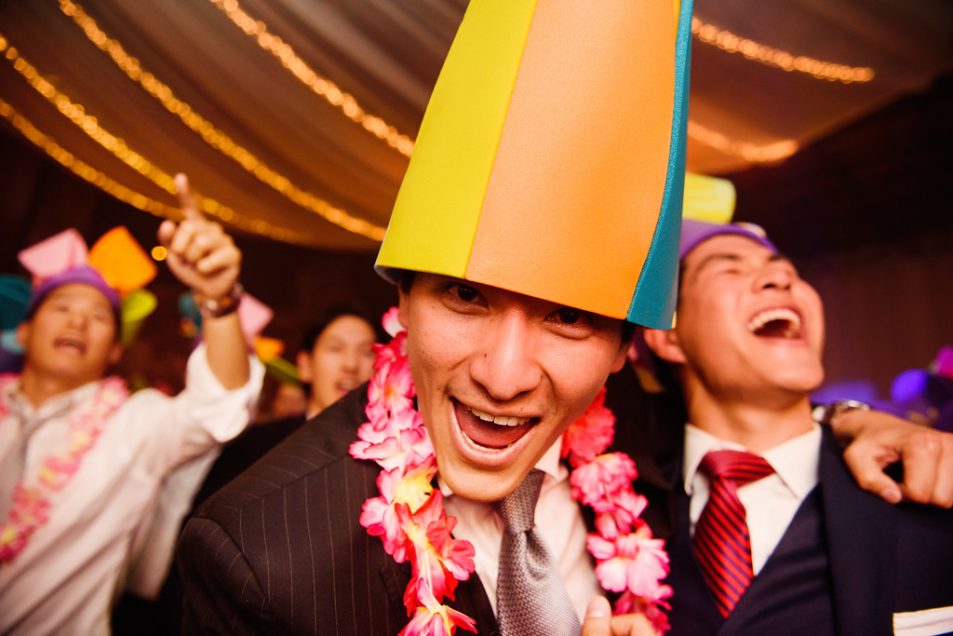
[350,308,672,636]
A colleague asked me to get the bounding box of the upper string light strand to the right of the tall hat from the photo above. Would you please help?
[692,17,874,84]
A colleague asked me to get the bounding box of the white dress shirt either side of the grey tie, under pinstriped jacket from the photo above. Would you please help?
[440,440,602,622]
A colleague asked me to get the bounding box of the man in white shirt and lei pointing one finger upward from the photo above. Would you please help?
[0,176,262,634]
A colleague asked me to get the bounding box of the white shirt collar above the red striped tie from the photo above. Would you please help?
[682,424,821,499]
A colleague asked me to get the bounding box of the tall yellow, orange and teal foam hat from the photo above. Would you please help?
[377,0,691,328]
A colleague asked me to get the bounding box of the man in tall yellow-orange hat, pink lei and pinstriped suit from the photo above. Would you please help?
[177,0,940,635]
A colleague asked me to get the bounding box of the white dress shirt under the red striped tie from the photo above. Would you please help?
[683,424,821,574]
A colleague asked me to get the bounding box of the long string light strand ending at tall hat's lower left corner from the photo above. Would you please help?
[60,0,384,242]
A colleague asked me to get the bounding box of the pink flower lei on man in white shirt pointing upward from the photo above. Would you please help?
[0,374,129,565]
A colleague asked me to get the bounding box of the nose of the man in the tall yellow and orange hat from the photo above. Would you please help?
[470,311,543,401]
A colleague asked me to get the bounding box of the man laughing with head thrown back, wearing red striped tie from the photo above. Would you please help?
[645,221,953,634]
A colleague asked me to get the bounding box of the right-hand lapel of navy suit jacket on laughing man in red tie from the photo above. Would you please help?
[819,428,897,634]
